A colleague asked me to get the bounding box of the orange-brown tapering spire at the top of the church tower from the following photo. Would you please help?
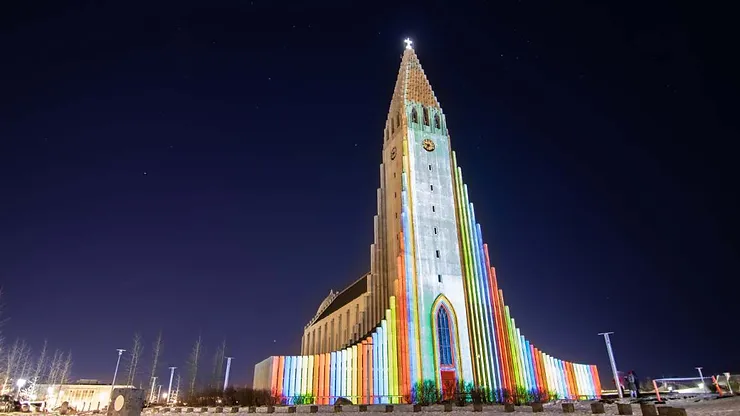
[391,46,440,109]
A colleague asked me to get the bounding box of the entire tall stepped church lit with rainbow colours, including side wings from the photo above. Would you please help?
[253,40,601,404]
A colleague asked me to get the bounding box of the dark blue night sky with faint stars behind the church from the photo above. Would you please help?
[0,0,740,384]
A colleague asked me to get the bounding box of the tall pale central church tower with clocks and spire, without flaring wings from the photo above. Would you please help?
[372,40,473,385]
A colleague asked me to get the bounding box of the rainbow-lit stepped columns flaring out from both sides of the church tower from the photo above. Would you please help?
[255,153,601,404]
